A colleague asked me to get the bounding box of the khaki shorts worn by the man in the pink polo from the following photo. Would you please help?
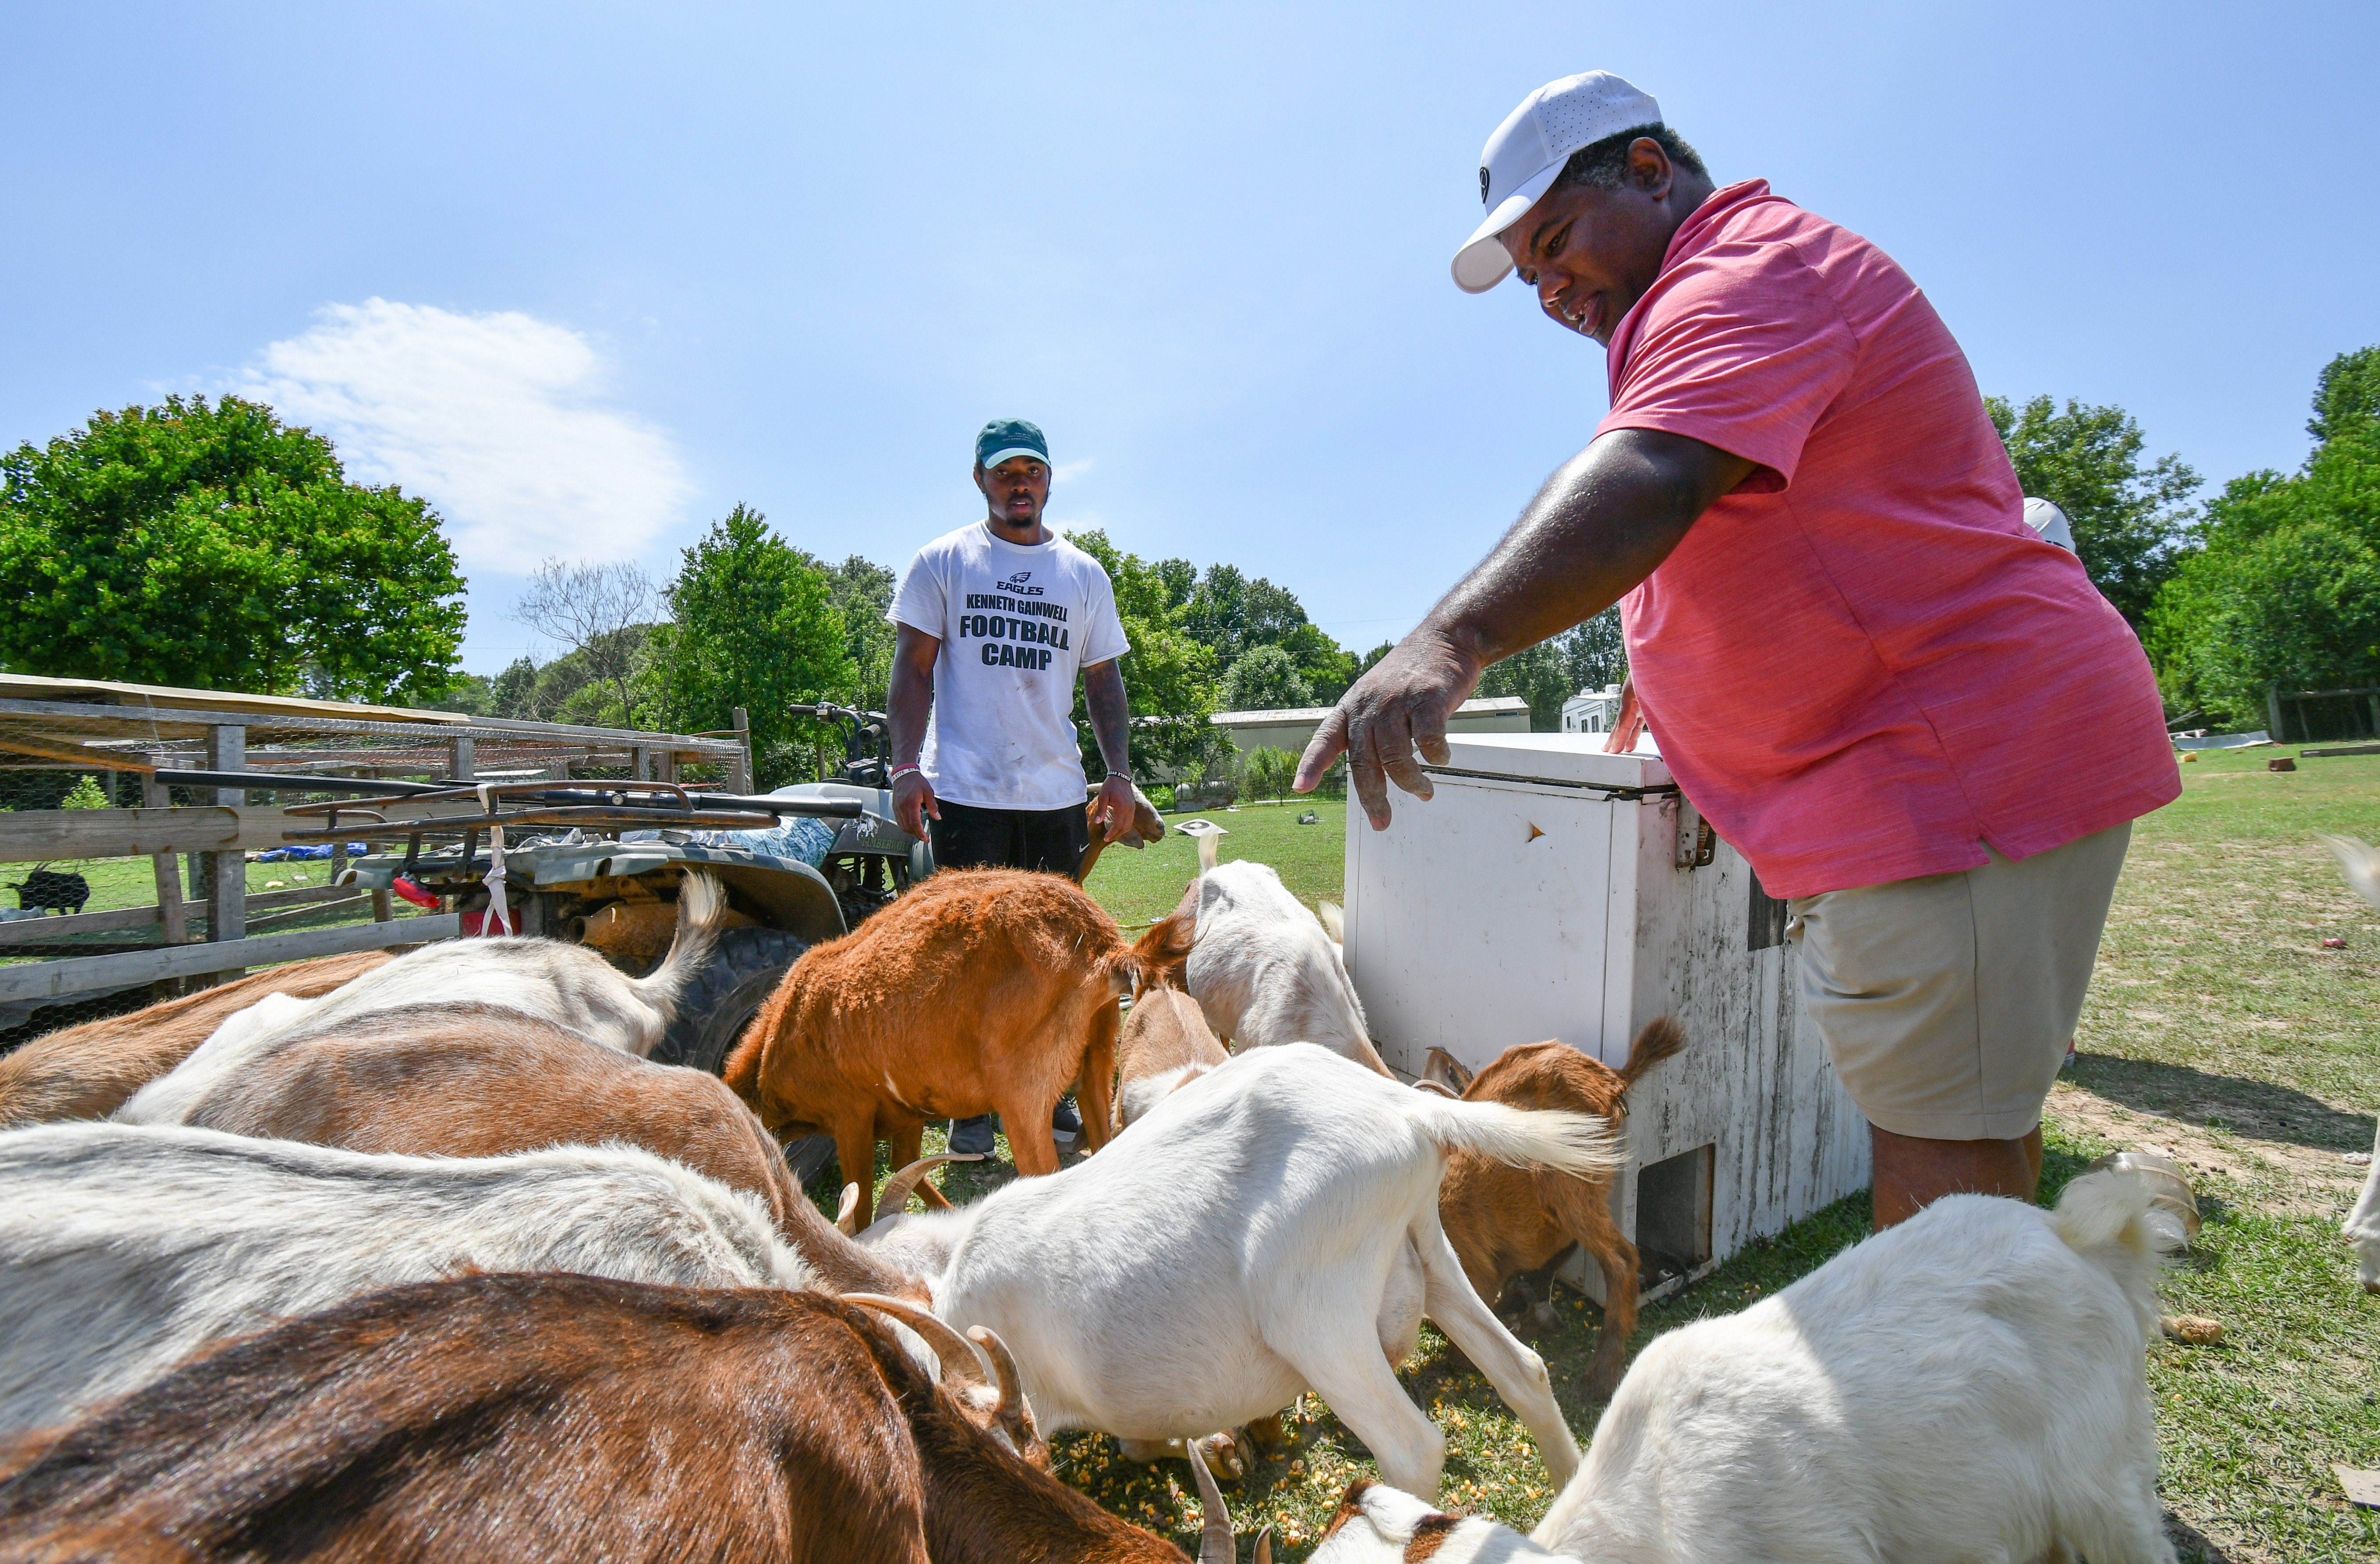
[1785,824,2132,1140]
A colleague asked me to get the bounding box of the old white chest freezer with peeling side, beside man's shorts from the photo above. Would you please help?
[1347,733,1868,1293]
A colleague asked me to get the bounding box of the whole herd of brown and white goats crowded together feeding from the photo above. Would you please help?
[0,828,2380,1564]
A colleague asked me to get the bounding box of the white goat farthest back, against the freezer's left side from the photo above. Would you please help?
[1183,859,1388,1076]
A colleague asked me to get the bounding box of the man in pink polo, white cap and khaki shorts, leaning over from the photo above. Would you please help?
[1297,71,2180,1226]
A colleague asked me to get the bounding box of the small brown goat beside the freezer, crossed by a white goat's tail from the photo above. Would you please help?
[1438,1016,1685,1395]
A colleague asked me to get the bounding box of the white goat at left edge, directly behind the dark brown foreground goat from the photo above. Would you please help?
[0,1124,812,1431]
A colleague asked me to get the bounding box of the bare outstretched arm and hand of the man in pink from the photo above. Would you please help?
[1297,428,1754,831]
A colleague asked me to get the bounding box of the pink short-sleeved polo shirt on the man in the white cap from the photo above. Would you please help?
[1595,179,2182,897]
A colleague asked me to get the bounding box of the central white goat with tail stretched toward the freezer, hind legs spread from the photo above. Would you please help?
[862,1043,1618,1493]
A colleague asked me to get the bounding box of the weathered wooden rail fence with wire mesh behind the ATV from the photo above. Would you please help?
[0,676,747,1052]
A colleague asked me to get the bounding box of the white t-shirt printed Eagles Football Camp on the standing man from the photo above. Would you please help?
[885,521,1133,809]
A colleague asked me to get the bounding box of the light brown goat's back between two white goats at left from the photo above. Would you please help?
[168,1005,926,1300]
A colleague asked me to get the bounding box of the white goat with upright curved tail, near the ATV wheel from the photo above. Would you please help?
[114,874,726,1124]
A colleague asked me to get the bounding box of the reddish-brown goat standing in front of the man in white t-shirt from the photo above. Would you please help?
[721,869,1176,1185]
